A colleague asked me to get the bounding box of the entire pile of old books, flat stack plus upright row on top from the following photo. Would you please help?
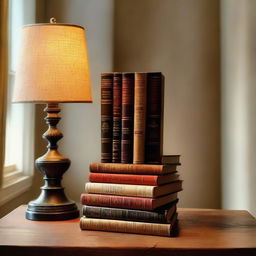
[80,72,182,236]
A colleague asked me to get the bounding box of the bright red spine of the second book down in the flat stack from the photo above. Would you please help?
[89,173,158,186]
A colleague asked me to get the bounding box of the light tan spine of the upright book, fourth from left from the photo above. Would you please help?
[133,73,147,164]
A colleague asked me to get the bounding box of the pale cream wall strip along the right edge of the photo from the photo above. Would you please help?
[221,0,256,216]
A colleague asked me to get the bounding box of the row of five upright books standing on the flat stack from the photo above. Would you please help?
[101,72,163,164]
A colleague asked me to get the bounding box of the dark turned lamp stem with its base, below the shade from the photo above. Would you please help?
[26,103,79,220]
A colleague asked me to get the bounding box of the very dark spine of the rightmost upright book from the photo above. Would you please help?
[145,72,162,164]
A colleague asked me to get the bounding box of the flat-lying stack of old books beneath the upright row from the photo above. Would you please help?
[80,156,182,236]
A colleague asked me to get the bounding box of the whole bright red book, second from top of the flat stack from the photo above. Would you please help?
[89,172,179,186]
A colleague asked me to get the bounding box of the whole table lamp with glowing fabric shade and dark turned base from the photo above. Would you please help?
[13,18,92,220]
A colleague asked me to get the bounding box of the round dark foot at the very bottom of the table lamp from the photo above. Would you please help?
[26,201,79,221]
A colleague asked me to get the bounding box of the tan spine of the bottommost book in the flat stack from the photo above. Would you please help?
[80,217,171,236]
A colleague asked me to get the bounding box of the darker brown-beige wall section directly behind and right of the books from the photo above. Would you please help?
[114,0,220,208]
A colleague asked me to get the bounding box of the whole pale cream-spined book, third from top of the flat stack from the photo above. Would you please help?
[85,180,182,198]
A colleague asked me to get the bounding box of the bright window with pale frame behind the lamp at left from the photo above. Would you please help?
[0,0,36,205]
